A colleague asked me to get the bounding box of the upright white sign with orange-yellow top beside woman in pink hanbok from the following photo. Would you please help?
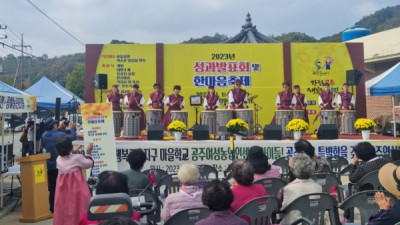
[81,102,118,177]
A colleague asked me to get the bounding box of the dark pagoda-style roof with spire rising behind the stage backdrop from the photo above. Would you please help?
[222,13,278,43]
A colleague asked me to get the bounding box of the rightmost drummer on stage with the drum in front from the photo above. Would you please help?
[337,83,356,134]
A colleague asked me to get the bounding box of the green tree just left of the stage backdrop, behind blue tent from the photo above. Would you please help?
[66,63,85,98]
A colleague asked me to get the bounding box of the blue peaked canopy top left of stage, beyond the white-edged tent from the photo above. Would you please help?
[25,76,84,110]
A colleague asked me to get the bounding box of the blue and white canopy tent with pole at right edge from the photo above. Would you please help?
[365,62,400,136]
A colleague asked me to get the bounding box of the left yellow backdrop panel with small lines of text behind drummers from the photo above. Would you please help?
[95,44,156,110]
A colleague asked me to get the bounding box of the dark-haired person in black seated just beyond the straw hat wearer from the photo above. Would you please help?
[349,142,389,185]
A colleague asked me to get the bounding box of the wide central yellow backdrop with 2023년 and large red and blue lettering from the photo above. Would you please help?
[164,44,283,127]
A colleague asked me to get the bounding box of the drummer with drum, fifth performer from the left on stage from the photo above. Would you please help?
[200,86,220,134]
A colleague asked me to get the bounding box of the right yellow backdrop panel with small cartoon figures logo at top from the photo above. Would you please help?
[291,43,357,133]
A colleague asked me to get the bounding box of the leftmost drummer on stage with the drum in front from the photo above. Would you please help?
[107,85,124,136]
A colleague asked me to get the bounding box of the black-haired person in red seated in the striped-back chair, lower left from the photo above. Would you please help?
[78,171,140,225]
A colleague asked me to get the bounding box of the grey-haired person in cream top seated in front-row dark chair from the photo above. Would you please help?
[281,153,322,224]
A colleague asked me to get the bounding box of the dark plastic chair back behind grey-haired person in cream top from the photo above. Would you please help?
[282,193,340,225]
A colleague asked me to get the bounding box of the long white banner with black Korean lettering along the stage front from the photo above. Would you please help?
[74,134,400,173]
